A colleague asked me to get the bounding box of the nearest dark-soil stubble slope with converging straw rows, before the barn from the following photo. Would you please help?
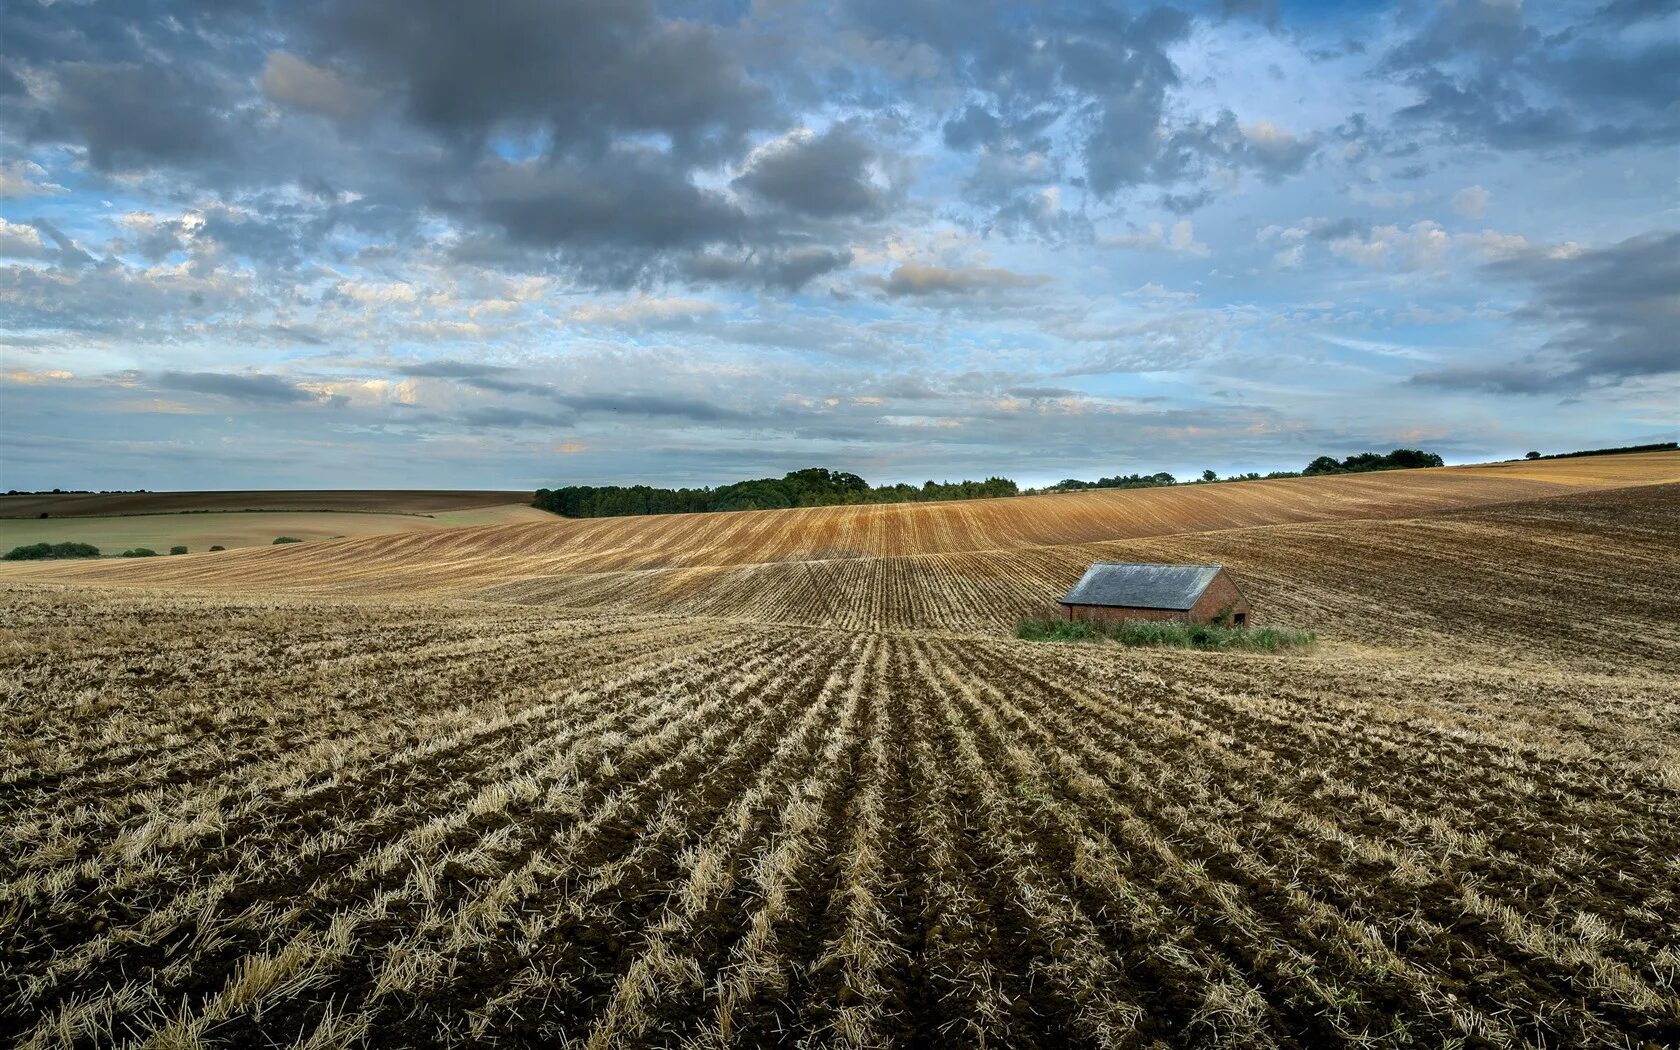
[0,583,1680,1047]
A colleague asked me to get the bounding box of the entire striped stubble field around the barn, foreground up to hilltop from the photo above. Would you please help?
[0,454,1680,1048]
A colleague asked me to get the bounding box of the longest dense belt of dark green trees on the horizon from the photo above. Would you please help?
[531,467,1020,517]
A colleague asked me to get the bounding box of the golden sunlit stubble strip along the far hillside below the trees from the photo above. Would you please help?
[13,452,1680,593]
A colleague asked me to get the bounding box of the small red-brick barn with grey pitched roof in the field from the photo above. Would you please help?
[1062,561,1248,627]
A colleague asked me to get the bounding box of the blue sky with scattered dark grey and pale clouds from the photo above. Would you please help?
[0,0,1680,491]
